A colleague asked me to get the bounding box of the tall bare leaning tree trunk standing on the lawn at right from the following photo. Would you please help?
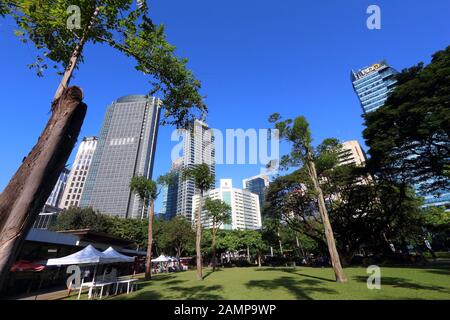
[307,152,347,282]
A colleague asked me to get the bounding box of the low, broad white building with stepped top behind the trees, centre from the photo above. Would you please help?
[192,179,262,230]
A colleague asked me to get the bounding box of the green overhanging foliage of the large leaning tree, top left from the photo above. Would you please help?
[7,0,207,127]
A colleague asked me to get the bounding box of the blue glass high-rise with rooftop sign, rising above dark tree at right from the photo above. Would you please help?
[351,61,397,113]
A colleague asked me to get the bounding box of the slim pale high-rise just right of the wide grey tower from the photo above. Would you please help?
[164,120,215,220]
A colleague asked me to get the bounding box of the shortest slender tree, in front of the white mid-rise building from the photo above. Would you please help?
[205,198,231,272]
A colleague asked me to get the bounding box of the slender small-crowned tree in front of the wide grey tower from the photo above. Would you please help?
[130,176,158,280]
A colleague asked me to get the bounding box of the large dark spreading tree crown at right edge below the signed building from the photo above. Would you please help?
[364,46,450,194]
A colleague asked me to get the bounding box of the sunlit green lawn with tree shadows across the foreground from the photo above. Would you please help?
[69,267,450,300]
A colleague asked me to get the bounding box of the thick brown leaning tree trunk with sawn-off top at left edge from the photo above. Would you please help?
[0,87,87,291]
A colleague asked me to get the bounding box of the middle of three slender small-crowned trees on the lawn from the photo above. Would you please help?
[182,163,215,280]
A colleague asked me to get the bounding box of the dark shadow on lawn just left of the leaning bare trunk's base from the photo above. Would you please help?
[246,277,337,300]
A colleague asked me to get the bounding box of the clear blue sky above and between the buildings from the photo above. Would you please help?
[0,0,450,210]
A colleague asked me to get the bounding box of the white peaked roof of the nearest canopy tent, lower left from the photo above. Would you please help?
[47,245,119,266]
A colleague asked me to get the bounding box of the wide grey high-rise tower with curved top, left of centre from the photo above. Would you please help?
[80,95,161,218]
